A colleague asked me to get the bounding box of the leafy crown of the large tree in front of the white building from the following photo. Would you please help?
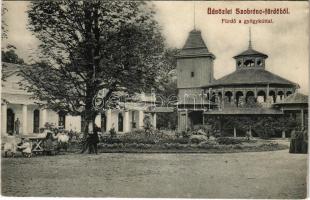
[22,0,164,131]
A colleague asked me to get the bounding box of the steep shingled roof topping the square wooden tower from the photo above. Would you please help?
[176,30,215,58]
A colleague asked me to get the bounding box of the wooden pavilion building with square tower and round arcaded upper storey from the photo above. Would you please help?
[177,30,308,134]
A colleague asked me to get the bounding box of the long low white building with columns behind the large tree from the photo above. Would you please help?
[1,63,156,135]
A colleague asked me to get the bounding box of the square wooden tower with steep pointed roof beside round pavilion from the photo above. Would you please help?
[176,29,215,130]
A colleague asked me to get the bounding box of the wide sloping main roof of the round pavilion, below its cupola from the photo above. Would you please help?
[206,69,299,87]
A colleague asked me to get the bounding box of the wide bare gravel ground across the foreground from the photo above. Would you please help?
[2,150,307,199]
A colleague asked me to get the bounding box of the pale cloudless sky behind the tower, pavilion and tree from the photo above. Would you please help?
[2,1,309,94]
